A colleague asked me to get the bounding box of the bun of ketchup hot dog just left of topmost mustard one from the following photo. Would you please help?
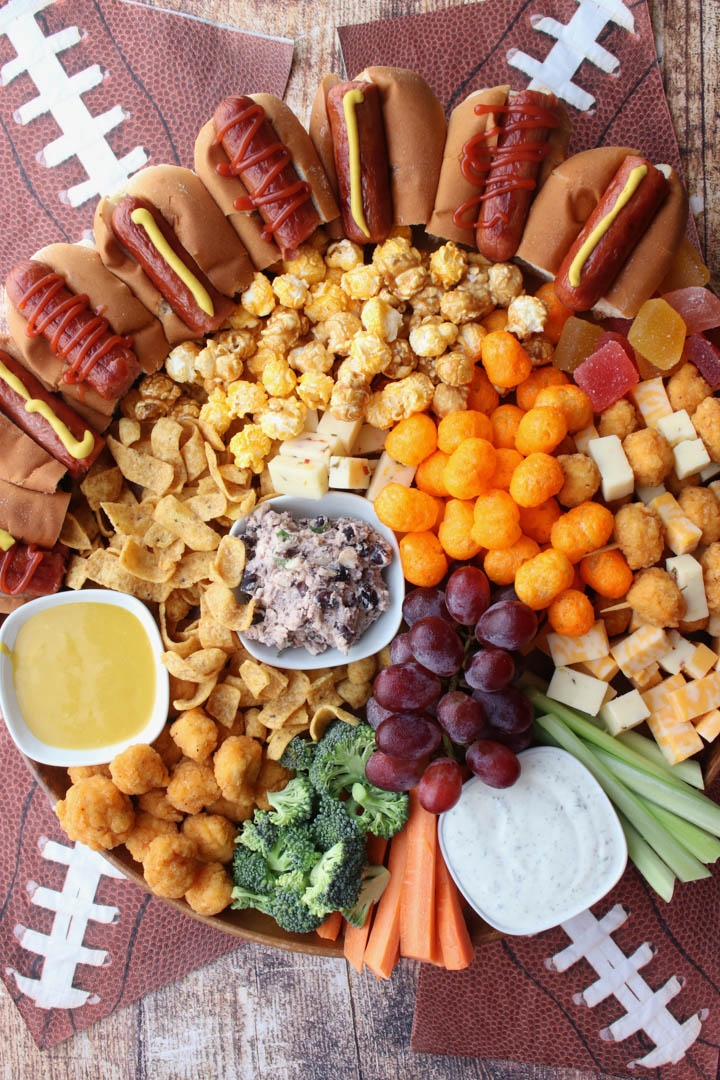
[194,94,340,270]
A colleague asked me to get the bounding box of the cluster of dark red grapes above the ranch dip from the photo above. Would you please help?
[366,566,538,813]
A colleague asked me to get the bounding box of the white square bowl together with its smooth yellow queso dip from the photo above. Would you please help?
[0,589,169,767]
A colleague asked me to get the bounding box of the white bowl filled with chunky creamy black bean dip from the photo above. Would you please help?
[232,491,405,671]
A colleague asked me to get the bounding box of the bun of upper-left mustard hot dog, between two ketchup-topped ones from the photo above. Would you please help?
[94,165,253,346]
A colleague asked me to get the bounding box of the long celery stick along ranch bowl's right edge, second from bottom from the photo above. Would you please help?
[534,715,710,881]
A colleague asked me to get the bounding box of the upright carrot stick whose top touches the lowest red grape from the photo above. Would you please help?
[400,789,437,963]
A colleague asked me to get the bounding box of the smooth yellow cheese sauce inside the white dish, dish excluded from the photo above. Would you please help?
[12,604,157,750]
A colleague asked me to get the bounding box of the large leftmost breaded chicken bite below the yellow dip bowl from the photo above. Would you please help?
[55,777,135,851]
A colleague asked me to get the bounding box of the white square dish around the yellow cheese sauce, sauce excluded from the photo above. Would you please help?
[0,589,169,768]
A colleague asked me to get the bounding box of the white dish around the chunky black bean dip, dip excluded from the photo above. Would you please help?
[230,491,405,671]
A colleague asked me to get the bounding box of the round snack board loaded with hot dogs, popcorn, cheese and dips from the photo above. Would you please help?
[0,67,720,977]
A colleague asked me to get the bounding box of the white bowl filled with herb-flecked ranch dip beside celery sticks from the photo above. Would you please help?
[438,746,627,934]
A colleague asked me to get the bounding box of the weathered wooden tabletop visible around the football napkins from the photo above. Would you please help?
[0,0,720,1080]
